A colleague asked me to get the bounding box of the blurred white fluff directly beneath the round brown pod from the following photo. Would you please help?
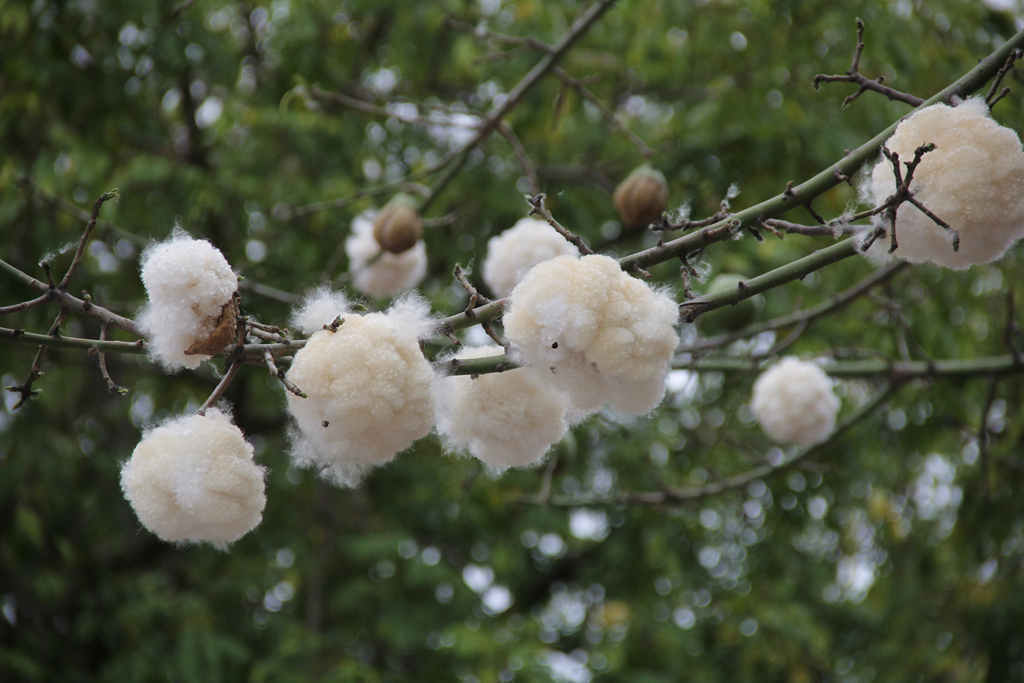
[345,212,427,299]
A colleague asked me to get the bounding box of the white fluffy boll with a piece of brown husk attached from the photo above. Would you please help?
[138,230,239,370]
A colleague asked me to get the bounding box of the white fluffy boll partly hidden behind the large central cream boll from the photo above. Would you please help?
[482,217,580,297]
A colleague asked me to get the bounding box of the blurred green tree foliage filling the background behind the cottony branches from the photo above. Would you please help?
[0,0,1024,681]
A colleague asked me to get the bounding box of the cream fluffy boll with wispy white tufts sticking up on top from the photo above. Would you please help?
[287,297,434,484]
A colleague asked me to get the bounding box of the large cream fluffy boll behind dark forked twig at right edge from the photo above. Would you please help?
[861,98,1024,269]
